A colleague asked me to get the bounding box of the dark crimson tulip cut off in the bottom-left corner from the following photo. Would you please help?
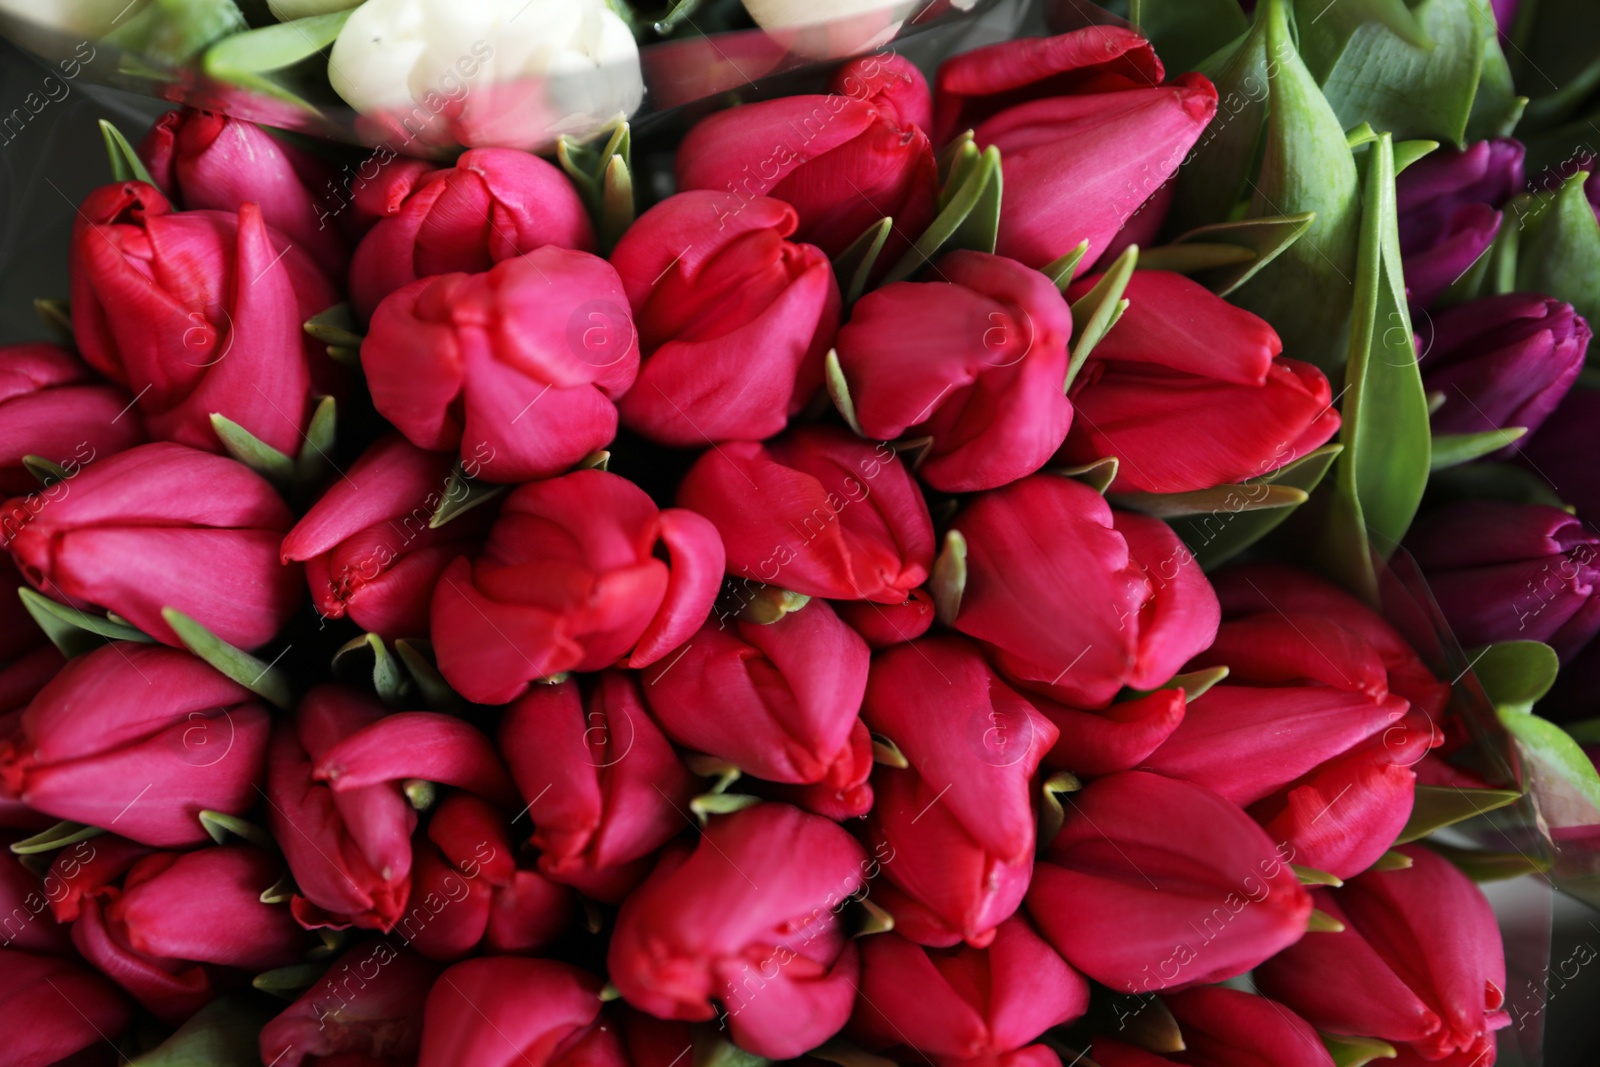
[0,949,133,1067]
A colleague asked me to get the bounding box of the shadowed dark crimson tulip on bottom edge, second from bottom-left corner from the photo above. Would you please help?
[261,941,438,1067]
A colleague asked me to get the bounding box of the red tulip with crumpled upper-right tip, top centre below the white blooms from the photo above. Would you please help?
[677,56,939,270]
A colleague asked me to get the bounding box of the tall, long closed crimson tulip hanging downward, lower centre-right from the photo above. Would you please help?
[861,637,1056,947]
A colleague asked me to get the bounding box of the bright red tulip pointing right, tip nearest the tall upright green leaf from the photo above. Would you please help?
[1062,270,1339,493]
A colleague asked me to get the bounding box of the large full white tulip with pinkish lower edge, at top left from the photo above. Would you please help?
[328,0,645,149]
